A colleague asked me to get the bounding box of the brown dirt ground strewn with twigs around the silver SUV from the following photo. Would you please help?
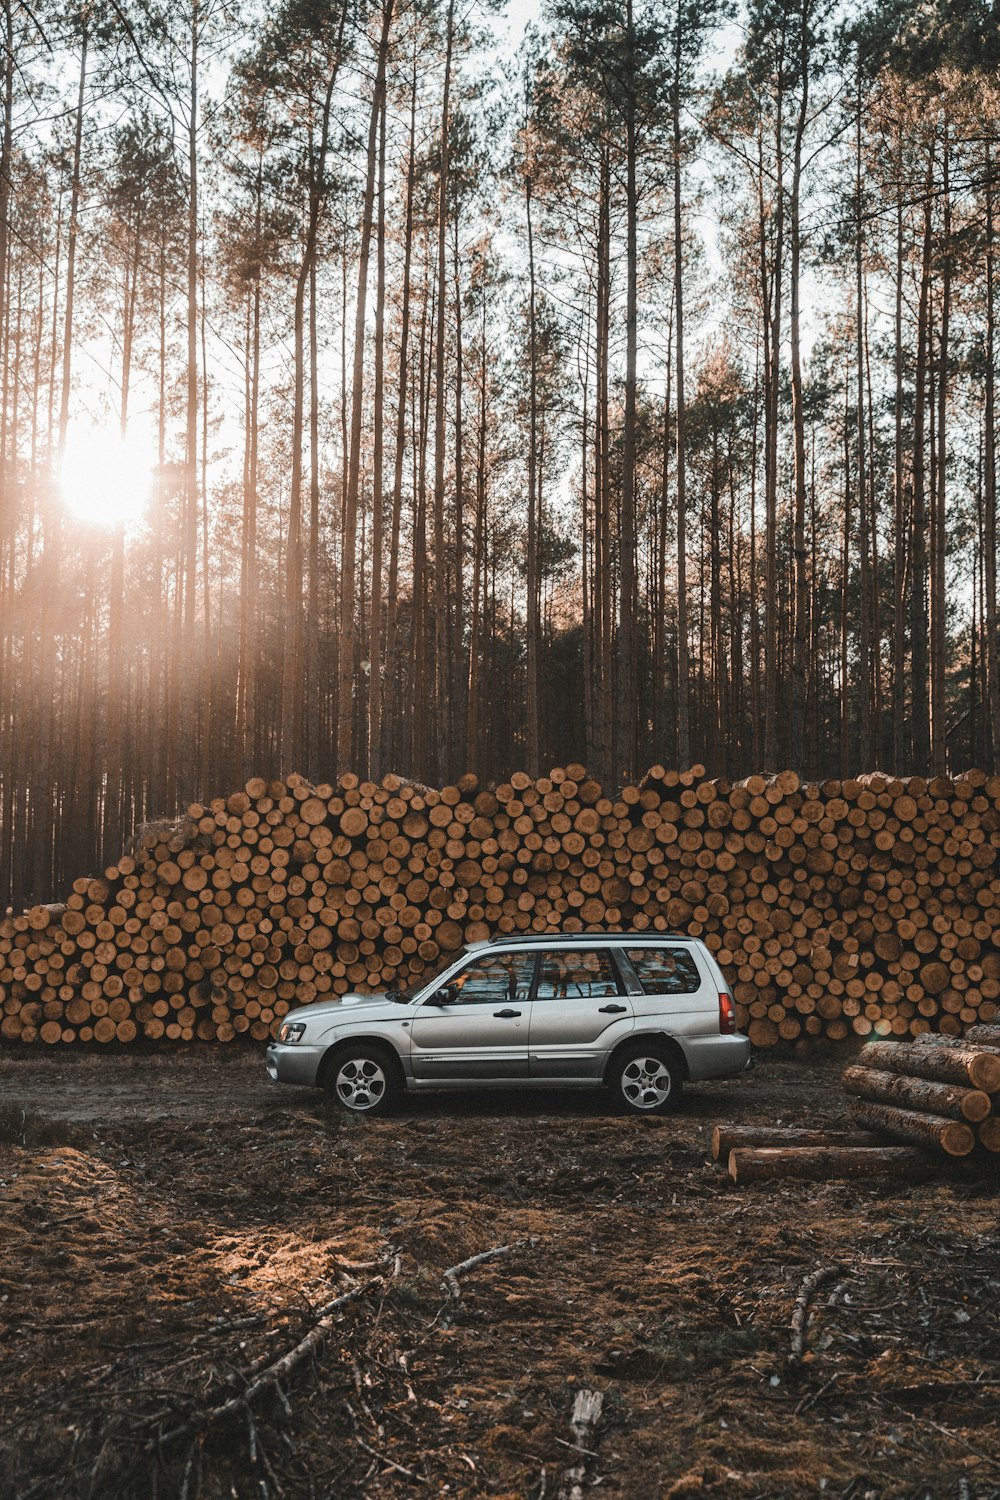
[0,1049,1000,1500]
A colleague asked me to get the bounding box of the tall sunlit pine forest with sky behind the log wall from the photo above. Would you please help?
[0,0,1000,905]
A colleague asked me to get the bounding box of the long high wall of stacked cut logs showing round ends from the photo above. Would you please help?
[0,765,1000,1047]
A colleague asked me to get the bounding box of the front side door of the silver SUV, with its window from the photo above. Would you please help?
[409,953,535,1080]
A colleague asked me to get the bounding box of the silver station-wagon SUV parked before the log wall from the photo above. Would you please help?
[267,933,750,1115]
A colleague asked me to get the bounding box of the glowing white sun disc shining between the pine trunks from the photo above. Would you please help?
[60,426,153,527]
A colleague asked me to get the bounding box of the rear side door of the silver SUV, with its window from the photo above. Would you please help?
[528,948,633,1079]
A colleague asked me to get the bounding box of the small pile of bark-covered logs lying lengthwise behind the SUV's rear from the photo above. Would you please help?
[844,1026,1000,1157]
